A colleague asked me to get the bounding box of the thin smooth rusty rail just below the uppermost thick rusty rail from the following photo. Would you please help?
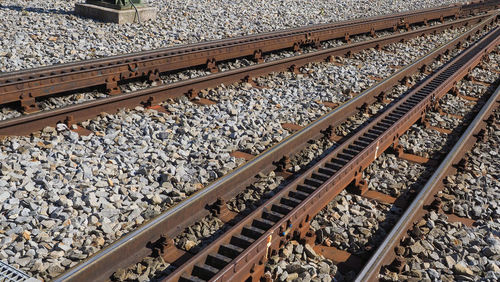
[0,14,496,136]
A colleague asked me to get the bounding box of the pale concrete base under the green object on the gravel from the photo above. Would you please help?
[75,3,157,24]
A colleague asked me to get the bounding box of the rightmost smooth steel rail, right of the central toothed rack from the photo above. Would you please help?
[356,80,500,281]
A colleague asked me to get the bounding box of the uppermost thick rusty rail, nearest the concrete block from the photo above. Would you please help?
[0,0,500,109]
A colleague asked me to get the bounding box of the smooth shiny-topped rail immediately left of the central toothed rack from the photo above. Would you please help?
[52,14,497,281]
